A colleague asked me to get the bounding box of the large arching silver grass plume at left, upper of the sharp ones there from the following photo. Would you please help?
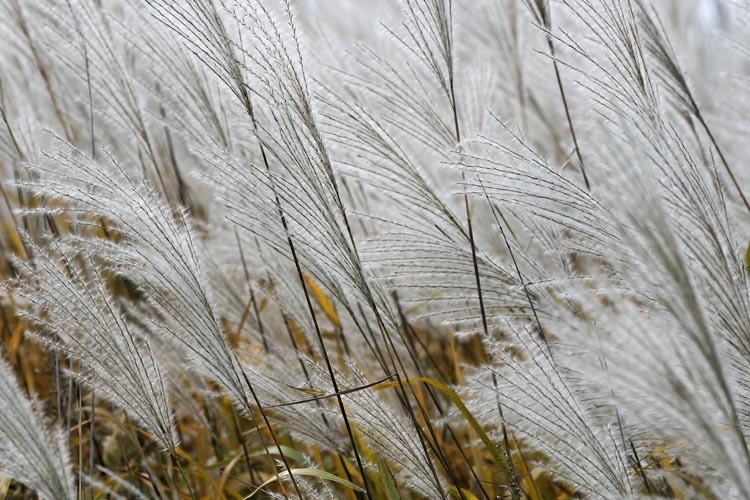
[16,138,245,403]
